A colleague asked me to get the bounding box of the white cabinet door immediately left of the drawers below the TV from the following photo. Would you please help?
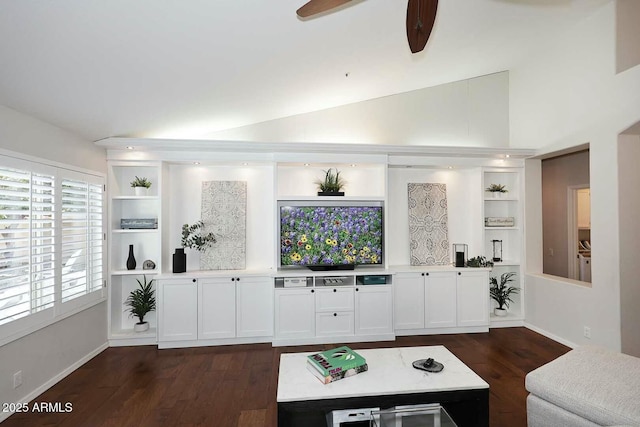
[275,288,316,339]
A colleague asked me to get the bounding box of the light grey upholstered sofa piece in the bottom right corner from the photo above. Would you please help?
[525,346,640,427]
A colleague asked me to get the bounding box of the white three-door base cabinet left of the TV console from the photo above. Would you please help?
[157,275,273,348]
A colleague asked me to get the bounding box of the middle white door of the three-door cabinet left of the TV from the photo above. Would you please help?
[198,277,236,340]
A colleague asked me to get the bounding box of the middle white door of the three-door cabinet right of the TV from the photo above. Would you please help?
[424,271,457,328]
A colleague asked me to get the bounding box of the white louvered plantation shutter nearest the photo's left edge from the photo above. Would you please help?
[0,167,55,324]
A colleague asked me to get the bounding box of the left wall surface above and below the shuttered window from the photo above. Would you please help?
[0,106,107,420]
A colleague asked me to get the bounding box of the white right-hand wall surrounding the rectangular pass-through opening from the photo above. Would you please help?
[510,2,640,350]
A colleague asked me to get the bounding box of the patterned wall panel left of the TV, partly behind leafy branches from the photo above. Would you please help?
[200,181,247,270]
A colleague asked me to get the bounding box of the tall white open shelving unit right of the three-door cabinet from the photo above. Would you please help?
[482,168,525,327]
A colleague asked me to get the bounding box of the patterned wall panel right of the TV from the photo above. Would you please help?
[408,183,450,265]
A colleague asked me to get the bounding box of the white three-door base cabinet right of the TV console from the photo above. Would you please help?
[394,267,489,335]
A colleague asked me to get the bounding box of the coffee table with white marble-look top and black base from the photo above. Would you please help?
[277,346,489,427]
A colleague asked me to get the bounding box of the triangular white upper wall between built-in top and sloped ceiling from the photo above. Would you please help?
[208,72,509,147]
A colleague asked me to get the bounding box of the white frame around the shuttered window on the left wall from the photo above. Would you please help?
[0,150,108,346]
